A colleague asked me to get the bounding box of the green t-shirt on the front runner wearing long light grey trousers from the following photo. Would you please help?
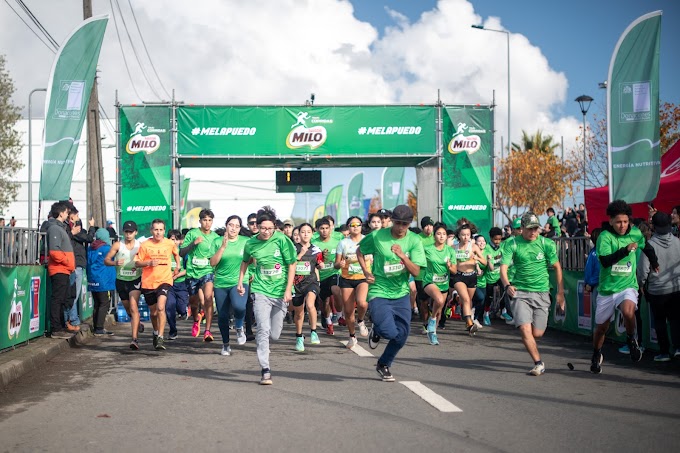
[243,231,297,299]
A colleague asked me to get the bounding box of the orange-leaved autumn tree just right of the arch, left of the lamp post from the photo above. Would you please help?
[496,149,580,221]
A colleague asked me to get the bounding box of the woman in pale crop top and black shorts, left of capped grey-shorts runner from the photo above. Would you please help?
[453,223,486,336]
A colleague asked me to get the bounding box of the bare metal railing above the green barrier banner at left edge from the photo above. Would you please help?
[0,227,45,266]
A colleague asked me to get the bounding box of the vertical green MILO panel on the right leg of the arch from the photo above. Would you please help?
[442,107,493,235]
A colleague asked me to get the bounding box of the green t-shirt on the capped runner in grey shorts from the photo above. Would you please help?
[501,235,557,292]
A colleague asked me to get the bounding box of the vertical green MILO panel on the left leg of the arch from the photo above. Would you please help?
[118,106,173,233]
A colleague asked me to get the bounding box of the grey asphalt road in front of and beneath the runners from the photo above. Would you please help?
[0,312,680,452]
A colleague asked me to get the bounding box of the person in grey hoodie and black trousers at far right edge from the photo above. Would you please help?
[637,212,680,362]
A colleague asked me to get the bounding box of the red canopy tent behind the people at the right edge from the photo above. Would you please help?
[586,140,680,232]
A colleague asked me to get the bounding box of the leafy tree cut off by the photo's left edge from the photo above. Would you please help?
[0,55,24,212]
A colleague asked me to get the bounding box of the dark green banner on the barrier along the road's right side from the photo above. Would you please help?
[548,271,659,351]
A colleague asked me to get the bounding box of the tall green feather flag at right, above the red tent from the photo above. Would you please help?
[607,11,661,203]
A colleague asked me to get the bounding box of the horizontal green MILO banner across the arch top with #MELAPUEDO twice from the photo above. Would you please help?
[177,106,436,158]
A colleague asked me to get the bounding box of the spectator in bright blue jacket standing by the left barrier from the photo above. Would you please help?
[87,228,116,336]
